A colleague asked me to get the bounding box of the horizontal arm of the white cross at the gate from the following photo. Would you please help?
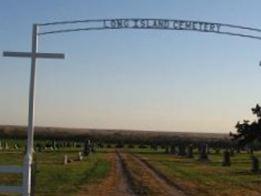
[3,51,65,59]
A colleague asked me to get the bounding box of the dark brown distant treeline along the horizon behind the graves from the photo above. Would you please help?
[0,125,231,145]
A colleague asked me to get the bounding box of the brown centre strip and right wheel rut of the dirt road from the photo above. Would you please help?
[118,152,185,196]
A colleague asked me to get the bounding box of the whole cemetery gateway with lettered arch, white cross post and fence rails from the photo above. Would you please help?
[0,18,261,196]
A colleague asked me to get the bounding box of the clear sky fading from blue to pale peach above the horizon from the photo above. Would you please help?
[0,0,261,133]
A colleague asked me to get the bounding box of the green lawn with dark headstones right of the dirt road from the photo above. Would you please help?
[131,149,261,195]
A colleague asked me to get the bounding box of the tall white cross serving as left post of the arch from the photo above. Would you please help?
[3,24,64,196]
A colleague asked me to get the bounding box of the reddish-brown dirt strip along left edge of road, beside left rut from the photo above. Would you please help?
[77,152,134,196]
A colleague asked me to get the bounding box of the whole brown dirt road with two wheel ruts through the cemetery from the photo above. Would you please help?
[79,150,185,196]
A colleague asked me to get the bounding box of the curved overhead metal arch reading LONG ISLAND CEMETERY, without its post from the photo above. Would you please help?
[37,18,261,40]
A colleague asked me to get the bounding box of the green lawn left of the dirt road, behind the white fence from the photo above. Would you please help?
[0,151,111,195]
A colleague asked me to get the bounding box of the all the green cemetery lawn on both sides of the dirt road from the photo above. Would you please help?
[0,148,261,196]
